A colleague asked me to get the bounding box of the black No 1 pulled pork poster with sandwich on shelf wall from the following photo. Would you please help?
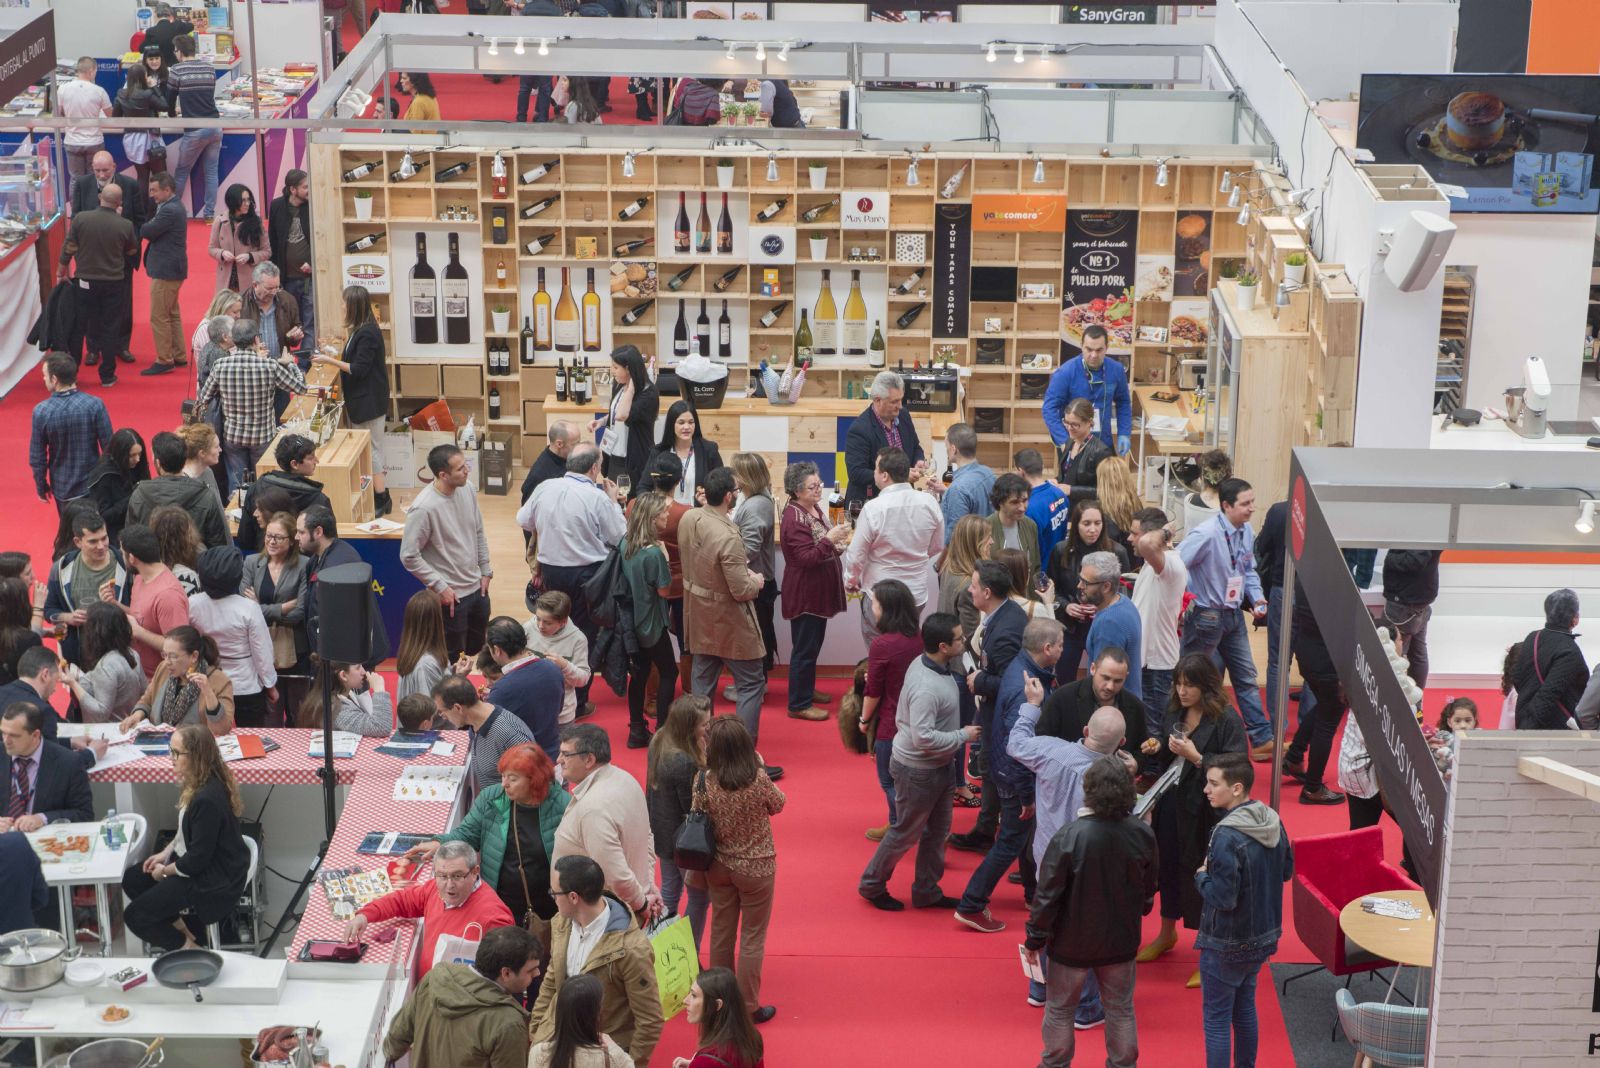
[1061,209,1139,360]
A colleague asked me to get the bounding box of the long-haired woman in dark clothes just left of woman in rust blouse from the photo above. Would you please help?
[645,694,710,950]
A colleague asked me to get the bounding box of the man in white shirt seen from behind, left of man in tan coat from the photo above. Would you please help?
[517,443,627,715]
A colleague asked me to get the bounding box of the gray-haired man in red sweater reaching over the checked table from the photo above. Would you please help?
[346,843,514,982]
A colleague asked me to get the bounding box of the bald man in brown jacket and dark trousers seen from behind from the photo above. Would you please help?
[56,184,139,385]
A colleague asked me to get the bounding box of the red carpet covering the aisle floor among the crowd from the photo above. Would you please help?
[0,224,1499,1068]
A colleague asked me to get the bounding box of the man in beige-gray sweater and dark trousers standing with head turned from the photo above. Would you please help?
[400,444,494,664]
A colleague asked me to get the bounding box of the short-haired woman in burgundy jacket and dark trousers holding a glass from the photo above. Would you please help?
[778,460,850,719]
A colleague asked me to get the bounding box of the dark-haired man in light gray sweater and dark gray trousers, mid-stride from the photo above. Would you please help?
[858,612,979,911]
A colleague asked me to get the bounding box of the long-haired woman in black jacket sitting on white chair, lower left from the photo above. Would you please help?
[122,724,250,950]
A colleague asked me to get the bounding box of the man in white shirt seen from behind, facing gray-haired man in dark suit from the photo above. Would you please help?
[845,448,944,646]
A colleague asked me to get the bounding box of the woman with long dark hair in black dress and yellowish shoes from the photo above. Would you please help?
[1139,652,1250,986]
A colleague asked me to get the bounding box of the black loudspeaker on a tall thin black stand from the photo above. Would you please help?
[261,563,373,956]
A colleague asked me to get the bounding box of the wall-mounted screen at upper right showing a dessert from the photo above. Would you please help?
[1355,74,1600,214]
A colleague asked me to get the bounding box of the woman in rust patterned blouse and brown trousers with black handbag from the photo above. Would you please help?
[694,716,786,1023]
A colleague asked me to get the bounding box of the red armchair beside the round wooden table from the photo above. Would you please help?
[1283,827,1421,990]
